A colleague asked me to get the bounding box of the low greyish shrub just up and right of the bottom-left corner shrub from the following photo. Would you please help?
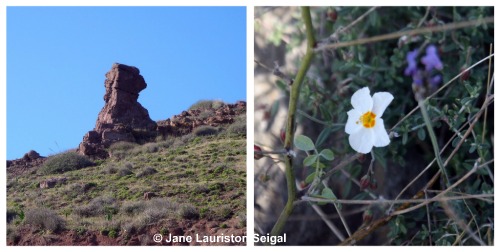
[73,196,118,217]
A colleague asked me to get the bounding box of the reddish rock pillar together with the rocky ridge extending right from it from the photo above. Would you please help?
[78,63,246,159]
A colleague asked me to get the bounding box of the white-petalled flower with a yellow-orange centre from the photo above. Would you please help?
[345,87,394,154]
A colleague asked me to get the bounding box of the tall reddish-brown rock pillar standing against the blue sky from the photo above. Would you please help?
[78,63,156,158]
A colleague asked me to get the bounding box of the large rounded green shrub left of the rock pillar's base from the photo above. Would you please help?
[39,152,94,174]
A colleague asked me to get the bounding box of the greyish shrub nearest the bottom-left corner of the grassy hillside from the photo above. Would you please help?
[24,208,65,232]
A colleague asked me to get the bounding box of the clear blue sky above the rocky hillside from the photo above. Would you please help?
[7,7,247,159]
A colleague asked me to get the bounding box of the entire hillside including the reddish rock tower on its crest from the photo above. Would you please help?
[3,62,246,245]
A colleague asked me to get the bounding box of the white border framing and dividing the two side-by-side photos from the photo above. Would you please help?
[0,0,500,251]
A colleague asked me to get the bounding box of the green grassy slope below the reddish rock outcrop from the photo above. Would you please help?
[7,105,246,245]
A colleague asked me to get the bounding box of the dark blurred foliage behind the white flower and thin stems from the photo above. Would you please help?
[254,7,494,245]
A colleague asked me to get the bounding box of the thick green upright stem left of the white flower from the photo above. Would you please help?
[271,7,316,236]
